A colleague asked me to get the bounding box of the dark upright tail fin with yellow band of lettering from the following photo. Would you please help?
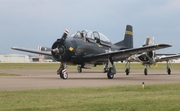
[114,25,133,49]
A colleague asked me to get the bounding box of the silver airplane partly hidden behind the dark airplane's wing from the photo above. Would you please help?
[125,36,180,75]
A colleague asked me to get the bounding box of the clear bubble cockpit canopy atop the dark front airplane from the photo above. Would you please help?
[70,30,111,43]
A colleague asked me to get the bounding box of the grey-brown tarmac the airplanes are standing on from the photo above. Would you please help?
[0,69,180,90]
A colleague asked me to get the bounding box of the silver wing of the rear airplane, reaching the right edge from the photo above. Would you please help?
[156,54,180,62]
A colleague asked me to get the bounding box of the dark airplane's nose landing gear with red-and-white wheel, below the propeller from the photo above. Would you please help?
[57,63,68,79]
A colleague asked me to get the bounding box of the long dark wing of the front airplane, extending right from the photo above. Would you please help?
[84,44,171,62]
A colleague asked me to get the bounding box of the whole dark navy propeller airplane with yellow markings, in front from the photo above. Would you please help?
[12,25,171,79]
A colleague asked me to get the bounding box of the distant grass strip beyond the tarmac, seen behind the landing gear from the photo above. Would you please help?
[0,63,180,70]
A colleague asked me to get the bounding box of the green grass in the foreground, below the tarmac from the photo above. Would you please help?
[0,84,180,111]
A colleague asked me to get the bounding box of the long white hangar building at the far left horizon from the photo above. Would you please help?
[0,54,30,63]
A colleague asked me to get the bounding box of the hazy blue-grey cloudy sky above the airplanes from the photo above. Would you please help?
[0,0,180,54]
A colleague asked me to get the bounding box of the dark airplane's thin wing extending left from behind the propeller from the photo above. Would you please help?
[11,47,52,56]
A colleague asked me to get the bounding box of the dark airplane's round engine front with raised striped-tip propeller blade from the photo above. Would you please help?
[51,29,69,61]
